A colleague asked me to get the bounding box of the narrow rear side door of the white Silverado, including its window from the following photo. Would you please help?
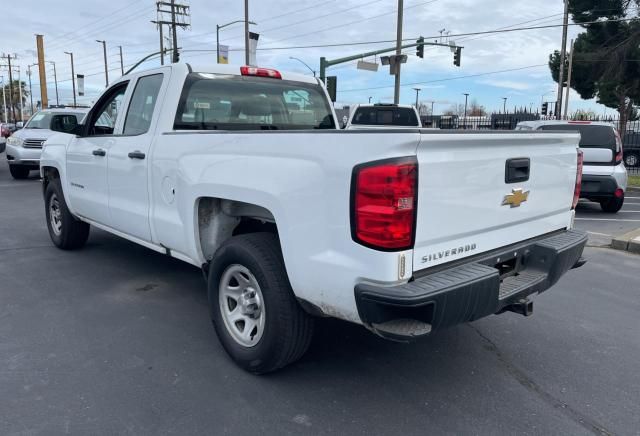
[108,73,166,242]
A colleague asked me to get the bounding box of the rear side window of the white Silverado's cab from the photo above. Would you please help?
[124,74,163,135]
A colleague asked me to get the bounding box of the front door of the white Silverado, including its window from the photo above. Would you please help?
[66,82,128,225]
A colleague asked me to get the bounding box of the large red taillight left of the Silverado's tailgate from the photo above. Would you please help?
[351,158,418,251]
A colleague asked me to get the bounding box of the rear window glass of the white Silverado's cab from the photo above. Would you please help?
[174,73,335,130]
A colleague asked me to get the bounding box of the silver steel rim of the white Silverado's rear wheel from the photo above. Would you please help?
[218,264,265,348]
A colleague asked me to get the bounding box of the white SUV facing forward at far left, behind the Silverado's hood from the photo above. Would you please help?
[7,109,88,179]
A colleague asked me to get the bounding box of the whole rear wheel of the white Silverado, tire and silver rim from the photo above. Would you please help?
[208,233,313,374]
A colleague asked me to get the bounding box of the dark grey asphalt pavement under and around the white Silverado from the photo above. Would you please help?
[0,155,640,435]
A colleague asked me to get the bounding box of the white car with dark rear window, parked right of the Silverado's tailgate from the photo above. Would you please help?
[516,121,627,213]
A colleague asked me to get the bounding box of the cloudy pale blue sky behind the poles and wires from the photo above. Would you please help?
[0,0,611,114]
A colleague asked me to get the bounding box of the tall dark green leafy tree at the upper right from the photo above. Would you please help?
[549,0,640,129]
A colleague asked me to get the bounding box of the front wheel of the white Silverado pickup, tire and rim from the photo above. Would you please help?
[44,179,90,250]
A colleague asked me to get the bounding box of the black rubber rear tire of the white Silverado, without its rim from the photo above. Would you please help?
[208,233,314,374]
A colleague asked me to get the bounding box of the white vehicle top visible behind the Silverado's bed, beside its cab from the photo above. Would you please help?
[344,103,422,130]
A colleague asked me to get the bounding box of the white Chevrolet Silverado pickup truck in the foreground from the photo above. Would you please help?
[41,64,586,373]
